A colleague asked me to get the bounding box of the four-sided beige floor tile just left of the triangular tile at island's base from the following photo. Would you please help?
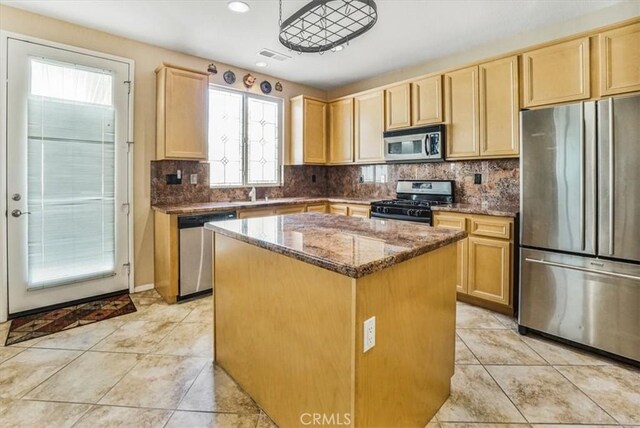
[99,355,207,409]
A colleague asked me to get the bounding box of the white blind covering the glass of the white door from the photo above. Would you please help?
[27,59,116,288]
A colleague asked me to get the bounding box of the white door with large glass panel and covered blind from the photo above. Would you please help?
[7,38,131,314]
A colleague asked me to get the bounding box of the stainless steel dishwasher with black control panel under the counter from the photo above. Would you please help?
[178,211,236,300]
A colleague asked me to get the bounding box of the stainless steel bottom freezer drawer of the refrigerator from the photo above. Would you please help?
[518,248,640,361]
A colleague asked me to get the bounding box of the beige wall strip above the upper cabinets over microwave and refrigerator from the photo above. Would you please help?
[327,0,640,99]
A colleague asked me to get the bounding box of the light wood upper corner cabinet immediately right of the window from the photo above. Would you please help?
[291,95,327,165]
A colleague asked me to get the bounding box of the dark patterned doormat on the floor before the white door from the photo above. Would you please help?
[5,294,136,346]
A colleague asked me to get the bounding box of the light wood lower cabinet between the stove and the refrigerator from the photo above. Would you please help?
[433,212,515,314]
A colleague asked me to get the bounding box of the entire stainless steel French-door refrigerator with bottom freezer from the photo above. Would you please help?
[518,95,640,361]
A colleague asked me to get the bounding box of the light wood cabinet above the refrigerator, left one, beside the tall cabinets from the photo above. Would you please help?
[522,37,591,107]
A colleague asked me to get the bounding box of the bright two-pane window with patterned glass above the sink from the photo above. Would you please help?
[209,88,282,187]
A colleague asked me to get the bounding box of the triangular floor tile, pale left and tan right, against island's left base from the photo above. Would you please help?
[178,363,260,414]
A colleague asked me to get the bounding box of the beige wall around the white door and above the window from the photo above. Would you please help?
[0,5,326,285]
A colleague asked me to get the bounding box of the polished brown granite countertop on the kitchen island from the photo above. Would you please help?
[205,213,467,278]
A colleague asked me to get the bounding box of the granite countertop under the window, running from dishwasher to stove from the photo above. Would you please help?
[151,196,380,214]
